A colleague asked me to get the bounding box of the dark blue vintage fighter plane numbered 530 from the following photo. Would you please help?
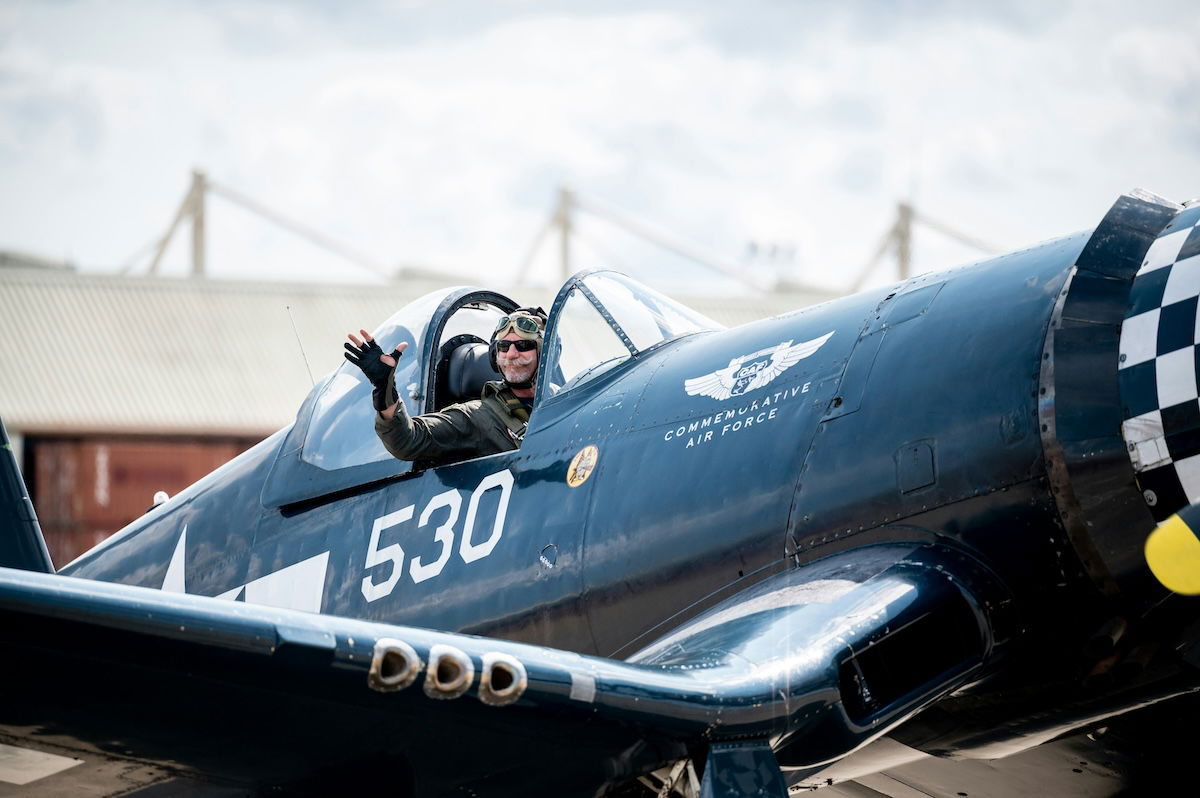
[0,192,1200,798]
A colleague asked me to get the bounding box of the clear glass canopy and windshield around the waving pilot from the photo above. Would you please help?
[263,270,720,505]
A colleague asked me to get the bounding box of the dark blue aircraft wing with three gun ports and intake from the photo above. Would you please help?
[0,545,992,796]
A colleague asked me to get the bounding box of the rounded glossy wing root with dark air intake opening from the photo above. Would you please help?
[619,545,1008,767]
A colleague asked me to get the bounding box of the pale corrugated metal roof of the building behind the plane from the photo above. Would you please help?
[0,268,828,436]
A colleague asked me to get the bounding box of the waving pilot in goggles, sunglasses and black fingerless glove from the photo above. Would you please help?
[344,307,546,462]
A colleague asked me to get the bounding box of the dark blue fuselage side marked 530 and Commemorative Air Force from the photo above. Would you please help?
[64,230,1132,656]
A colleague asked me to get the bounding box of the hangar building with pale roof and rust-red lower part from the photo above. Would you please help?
[0,257,830,568]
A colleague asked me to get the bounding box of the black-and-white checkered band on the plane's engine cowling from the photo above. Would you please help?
[1118,205,1200,520]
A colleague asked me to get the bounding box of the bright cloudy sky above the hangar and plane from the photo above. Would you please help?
[0,0,1200,294]
